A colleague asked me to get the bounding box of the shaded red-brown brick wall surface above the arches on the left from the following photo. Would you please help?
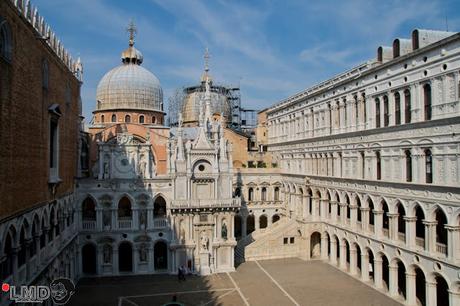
[0,1,80,219]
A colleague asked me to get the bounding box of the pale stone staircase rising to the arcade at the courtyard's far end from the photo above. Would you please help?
[235,218,298,265]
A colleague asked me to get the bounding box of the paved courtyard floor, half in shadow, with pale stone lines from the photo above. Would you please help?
[70,258,400,306]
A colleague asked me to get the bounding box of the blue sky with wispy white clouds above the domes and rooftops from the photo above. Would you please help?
[33,0,460,119]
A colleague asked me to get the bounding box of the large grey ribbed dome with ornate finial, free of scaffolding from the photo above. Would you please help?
[96,23,163,111]
